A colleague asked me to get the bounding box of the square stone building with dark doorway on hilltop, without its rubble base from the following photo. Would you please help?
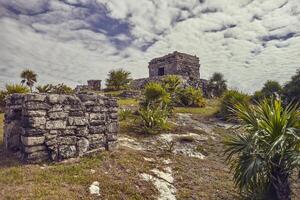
[148,51,200,79]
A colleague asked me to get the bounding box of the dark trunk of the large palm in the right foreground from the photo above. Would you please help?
[271,167,291,200]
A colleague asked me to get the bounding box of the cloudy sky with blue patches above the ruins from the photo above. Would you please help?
[0,0,300,92]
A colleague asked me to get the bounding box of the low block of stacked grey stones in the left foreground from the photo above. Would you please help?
[4,93,118,163]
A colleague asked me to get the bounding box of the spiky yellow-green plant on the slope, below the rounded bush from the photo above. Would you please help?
[139,104,169,133]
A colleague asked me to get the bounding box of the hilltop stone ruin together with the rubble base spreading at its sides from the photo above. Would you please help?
[131,51,207,95]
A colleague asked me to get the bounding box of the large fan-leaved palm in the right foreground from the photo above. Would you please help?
[225,99,300,200]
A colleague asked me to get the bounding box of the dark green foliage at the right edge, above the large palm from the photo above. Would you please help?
[284,69,300,102]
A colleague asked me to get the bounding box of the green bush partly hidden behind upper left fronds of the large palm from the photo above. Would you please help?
[218,90,250,120]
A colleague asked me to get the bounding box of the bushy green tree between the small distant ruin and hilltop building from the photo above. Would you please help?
[106,69,131,90]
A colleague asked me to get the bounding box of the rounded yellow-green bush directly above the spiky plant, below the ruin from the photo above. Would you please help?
[141,82,171,107]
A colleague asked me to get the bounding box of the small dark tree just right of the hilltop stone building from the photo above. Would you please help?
[207,72,227,97]
